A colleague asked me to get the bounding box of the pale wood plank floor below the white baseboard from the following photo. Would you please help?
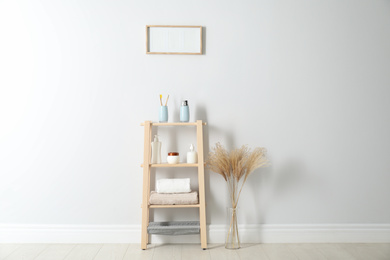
[0,244,390,260]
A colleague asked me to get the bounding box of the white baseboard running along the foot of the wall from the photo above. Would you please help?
[0,224,390,243]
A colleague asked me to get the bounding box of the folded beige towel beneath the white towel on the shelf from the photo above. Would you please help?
[149,191,199,205]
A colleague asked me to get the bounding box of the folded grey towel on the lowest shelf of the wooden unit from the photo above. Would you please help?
[148,221,200,236]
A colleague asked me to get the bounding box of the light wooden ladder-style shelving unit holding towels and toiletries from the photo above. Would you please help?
[141,120,207,249]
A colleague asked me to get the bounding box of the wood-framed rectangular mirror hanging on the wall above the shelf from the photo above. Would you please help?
[146,25,203,55]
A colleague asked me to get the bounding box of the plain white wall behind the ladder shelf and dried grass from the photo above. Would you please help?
[0,0,390,242]
